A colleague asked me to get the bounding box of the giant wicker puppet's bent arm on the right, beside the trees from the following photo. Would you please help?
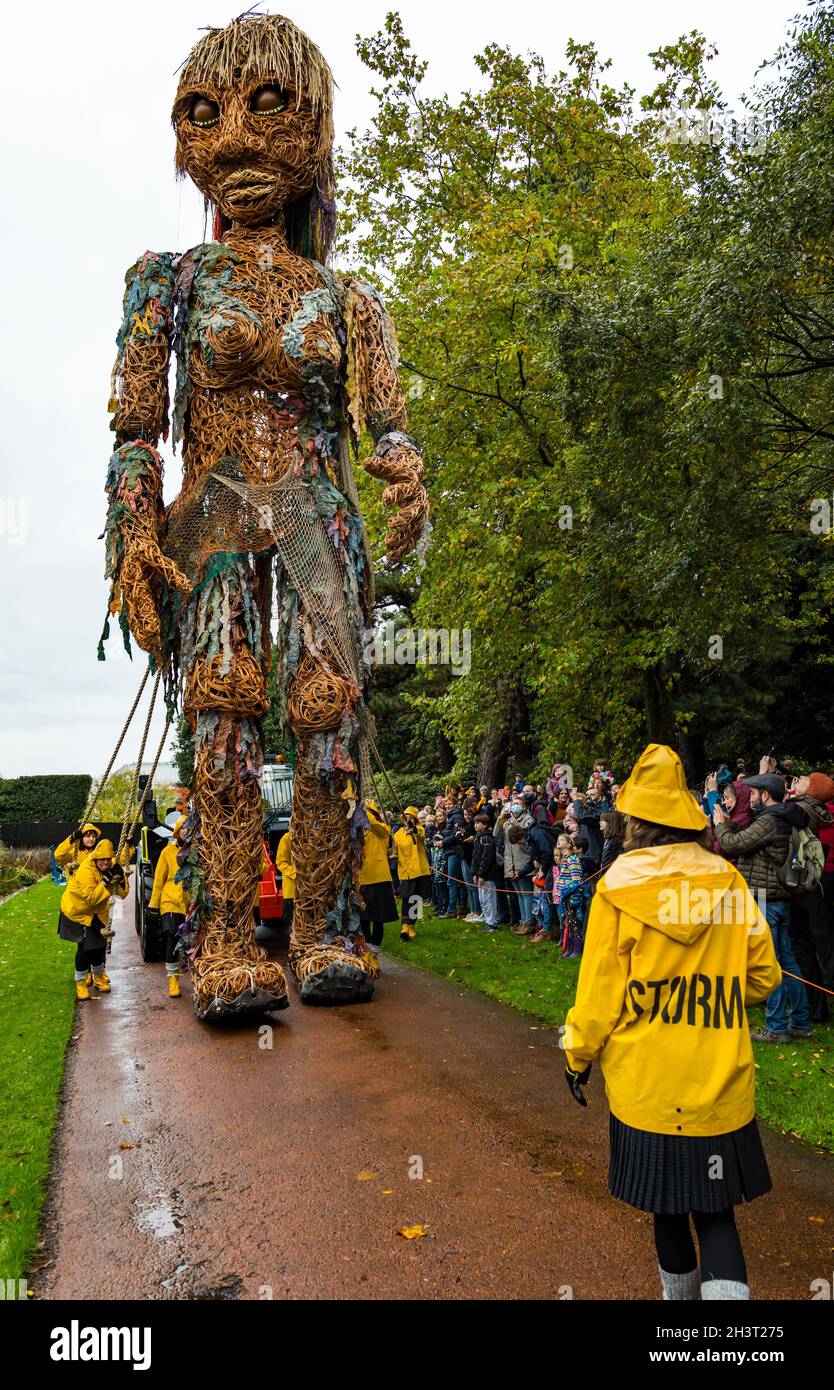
[345,279,428,564]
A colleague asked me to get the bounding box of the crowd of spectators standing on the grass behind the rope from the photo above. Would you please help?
[392,755,834,1043]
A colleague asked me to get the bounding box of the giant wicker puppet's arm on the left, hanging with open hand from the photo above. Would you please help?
[100,252,190,663]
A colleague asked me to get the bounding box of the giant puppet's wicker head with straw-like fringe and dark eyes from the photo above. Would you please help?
[171,14,335,261]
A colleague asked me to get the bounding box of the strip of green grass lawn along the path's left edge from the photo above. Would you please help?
[0,878,75,1279]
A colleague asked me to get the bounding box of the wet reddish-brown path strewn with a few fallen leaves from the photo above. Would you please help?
[31,899,834,1300]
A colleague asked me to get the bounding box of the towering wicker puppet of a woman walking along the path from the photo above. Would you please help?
[106,15,428,1017]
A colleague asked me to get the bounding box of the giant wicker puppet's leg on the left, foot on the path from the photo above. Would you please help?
[182,556,289,1019]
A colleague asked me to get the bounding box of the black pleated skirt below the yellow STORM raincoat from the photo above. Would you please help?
[609,1115,771,1216]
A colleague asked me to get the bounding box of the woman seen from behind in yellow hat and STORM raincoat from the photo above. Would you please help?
[564,744,781,1301]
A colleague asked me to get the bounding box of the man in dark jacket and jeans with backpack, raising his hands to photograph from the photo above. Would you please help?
[713,773,810,1043]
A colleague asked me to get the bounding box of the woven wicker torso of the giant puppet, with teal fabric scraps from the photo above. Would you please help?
[177,232,345,492]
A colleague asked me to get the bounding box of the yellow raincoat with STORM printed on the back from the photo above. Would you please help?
[564,842,781,1136]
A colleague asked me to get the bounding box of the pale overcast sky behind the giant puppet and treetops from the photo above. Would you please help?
[0,0,801,777]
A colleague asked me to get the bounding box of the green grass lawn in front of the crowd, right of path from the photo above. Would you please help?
[385,912,834,1152]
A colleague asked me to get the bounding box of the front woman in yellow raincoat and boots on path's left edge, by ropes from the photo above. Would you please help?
[58,840,128,999]
